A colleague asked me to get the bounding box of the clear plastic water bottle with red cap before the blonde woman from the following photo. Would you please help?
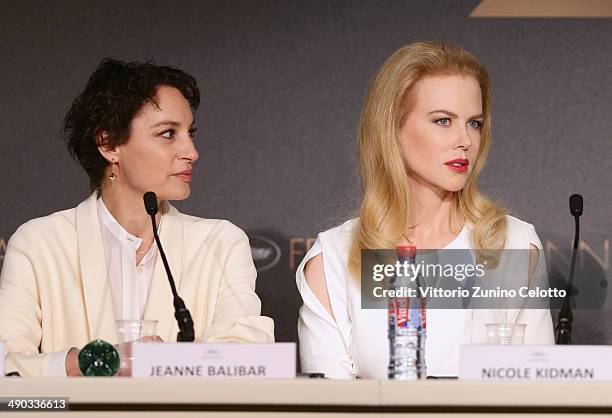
[388,245,427,380]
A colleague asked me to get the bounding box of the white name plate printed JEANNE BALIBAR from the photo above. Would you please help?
[132,343,296,379]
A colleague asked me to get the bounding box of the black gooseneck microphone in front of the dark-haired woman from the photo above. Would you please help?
[143,192,195,342]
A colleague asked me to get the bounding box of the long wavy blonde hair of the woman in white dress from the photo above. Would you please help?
[349,41,507,279]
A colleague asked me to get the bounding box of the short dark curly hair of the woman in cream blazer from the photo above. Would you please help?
[61,58,200,191]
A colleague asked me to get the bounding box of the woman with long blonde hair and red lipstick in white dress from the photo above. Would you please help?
[296,42,554,379]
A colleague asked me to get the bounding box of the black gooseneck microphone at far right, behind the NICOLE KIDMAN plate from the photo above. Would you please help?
[555,194,582,345]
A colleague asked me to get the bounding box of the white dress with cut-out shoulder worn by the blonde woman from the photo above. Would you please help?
[296,216,554,379]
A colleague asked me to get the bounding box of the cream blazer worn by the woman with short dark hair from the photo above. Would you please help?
[0,193,274,376]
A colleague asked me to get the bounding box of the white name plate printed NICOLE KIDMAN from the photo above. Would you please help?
[459,345,612,380]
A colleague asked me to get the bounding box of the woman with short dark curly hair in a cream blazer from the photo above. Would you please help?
[0,59,274,376]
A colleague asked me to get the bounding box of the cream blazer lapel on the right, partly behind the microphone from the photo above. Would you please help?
[143,201,183,341]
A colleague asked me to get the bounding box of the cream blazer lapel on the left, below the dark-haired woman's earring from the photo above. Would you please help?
[76,192,117,343]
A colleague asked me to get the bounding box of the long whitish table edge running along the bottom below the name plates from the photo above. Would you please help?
[0,378,612,418]
